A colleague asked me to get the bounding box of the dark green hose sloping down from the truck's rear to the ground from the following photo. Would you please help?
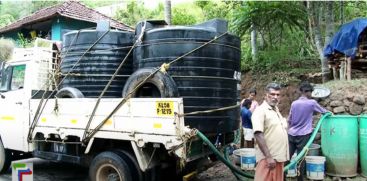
[195,130,254,178]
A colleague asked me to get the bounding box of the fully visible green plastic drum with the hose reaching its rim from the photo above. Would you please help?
[321,115,358,177]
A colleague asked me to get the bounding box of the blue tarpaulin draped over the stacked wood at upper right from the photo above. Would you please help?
[324,18,367,59]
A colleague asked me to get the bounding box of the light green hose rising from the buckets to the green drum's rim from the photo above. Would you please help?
[283,112,331,172]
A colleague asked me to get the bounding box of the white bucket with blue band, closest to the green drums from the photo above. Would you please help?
[306,156,325,180]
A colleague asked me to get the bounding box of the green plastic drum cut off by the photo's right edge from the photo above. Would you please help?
[359,115,367,177]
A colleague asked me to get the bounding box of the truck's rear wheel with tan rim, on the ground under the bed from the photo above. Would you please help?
[89,151,132,181]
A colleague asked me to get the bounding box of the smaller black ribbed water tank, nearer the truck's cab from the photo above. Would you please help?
[61,30,134,97]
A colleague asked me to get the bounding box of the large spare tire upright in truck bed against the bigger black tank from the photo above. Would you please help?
[122,68,178,97]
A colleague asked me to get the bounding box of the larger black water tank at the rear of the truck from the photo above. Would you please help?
[134,19,241,133]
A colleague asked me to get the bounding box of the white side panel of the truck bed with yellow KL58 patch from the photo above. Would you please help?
[30,98,185,149]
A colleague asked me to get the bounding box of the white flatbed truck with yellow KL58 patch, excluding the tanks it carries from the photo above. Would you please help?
[0,40,210,181]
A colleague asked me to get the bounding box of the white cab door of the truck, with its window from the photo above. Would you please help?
[0,64,29,151]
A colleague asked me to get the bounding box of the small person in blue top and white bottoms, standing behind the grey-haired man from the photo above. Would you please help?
[241,99,254,148]
